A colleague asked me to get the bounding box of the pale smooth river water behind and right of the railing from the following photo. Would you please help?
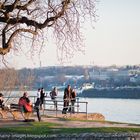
[5,91,140,124]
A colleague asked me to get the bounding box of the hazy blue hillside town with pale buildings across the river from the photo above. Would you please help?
[17,65,140,90]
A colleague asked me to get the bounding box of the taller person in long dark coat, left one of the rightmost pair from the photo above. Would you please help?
[62,85,72,114]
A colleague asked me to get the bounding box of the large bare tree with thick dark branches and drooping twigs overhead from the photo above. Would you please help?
[0,0,96,59]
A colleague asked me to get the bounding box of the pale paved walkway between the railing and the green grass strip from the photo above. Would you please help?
[0,115,140,128]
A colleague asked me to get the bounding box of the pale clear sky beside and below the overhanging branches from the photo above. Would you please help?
[1,0,140,68]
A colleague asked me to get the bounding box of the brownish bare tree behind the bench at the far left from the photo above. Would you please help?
[0,68,34,103]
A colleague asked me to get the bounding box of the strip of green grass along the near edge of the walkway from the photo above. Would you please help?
[0,122,140,135]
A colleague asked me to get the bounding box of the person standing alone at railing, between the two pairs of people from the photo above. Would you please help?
[50,87,58,110]
